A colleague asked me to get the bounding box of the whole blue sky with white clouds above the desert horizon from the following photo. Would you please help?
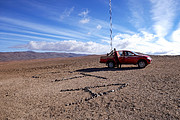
[0,0,180,55]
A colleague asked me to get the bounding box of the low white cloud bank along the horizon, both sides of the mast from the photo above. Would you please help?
[16,31,180,55]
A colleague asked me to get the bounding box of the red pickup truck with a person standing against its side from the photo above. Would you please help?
[100,50,152,68]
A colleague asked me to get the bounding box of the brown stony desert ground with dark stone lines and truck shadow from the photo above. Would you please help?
[0,56,180,120]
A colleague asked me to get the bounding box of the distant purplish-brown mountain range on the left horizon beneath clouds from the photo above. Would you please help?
[0,51,86,62]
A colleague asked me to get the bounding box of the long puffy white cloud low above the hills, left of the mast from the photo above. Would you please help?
[23,40,108,54]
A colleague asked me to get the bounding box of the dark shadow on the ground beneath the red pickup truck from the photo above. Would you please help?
[76,67,140,72]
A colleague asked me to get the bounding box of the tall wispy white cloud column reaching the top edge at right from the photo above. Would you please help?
[150,0,177,37]
